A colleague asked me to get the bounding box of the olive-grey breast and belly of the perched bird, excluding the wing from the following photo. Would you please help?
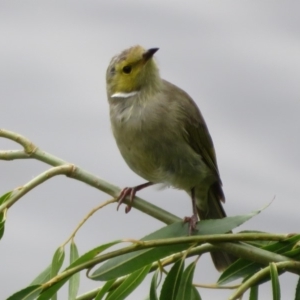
[110,98,210,189]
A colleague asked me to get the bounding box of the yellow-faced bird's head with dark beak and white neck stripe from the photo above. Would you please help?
[106,46,160,98]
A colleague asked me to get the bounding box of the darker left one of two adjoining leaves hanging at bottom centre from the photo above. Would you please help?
[159,259,184,300]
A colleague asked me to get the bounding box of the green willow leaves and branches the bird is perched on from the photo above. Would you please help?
[0,130,300,300]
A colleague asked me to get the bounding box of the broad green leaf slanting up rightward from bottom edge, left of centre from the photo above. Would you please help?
[106,265,151,300]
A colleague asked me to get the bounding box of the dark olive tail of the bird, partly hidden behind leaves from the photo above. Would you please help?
[197,183,237,272]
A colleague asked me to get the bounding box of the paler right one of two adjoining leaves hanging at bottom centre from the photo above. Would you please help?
[176,261,200,300]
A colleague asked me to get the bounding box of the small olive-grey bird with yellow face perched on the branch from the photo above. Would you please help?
[106,45,235,271]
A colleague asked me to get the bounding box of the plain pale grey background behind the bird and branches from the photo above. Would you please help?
[0,0,300,300]
